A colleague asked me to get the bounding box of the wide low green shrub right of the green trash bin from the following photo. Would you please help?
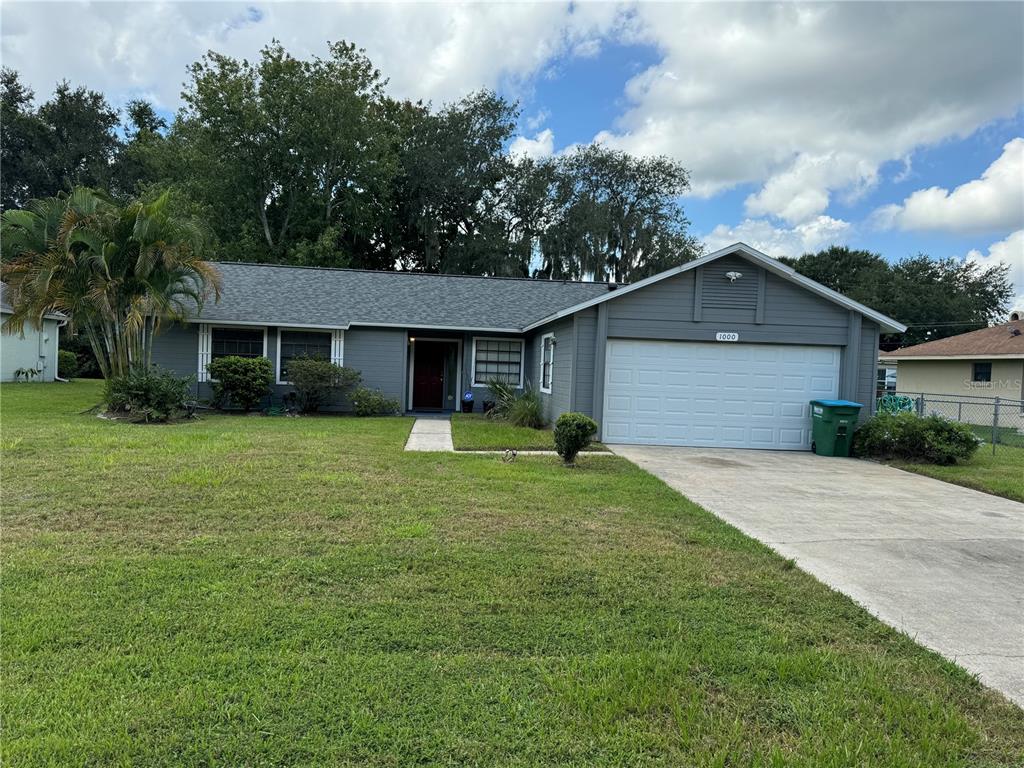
[853,413,981,464]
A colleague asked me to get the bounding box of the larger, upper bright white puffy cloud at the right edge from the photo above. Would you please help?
[873,138,1024,232]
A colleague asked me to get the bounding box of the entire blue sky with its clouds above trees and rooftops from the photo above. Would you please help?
[0,1,1024,305]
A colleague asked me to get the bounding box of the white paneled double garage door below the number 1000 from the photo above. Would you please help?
[602,339,840,451]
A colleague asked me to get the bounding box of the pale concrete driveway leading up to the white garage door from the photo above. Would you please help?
[609,445,1024,706]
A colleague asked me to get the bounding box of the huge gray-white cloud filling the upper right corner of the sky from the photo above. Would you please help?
[599,3,1024,214]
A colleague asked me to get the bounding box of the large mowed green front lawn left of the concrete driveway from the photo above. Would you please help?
[6,382,1024,767]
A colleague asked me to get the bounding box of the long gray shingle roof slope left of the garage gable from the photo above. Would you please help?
[199,262,608,331]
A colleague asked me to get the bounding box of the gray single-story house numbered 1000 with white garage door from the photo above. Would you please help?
[154,244,905,450]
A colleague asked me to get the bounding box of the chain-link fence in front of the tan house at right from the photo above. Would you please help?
[877,392,1024,453]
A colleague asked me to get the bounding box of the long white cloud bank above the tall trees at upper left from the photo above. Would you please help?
[0,1,622,109]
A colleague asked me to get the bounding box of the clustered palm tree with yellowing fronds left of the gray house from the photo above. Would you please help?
[0,187,220,378]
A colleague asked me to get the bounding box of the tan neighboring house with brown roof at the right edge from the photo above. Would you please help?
[879,319,1024,426]
